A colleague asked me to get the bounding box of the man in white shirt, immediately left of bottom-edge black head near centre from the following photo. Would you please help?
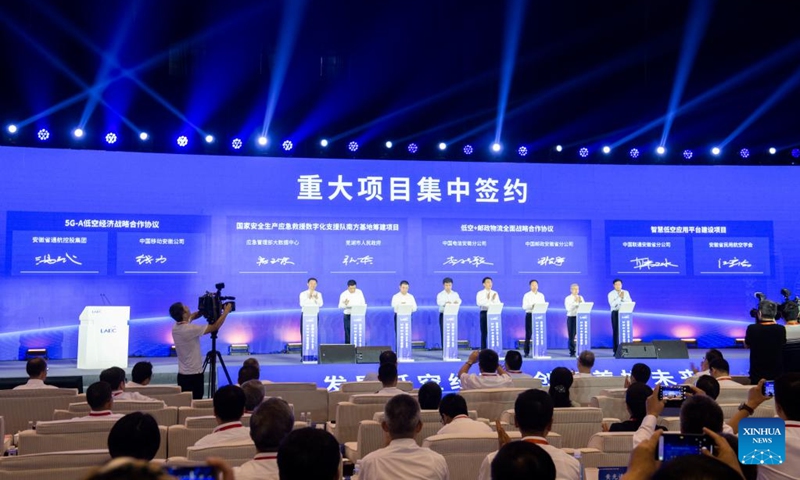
[234,398,296,480]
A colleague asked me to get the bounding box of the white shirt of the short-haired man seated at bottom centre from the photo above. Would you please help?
[358,438,450,480]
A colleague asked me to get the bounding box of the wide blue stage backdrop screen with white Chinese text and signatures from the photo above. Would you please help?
[0,147,800,359]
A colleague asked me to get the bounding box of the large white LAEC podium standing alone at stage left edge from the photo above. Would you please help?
[78,305,131,369]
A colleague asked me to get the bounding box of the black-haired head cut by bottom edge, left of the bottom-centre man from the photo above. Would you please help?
[278,428,340,480]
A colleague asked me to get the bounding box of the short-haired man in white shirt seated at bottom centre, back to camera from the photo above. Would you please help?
[358,392,450,480]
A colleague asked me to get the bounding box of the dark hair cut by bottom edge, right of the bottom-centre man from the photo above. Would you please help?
[492,442,556,480]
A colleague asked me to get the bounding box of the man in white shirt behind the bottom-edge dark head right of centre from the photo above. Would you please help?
[478,390,581,480]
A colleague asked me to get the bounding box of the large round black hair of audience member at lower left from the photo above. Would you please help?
[108,412,161,461]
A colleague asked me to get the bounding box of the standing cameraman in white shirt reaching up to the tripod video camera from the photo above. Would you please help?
[169,302,233,399]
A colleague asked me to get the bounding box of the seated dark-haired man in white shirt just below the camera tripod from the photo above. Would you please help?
[194,385,252,447]
